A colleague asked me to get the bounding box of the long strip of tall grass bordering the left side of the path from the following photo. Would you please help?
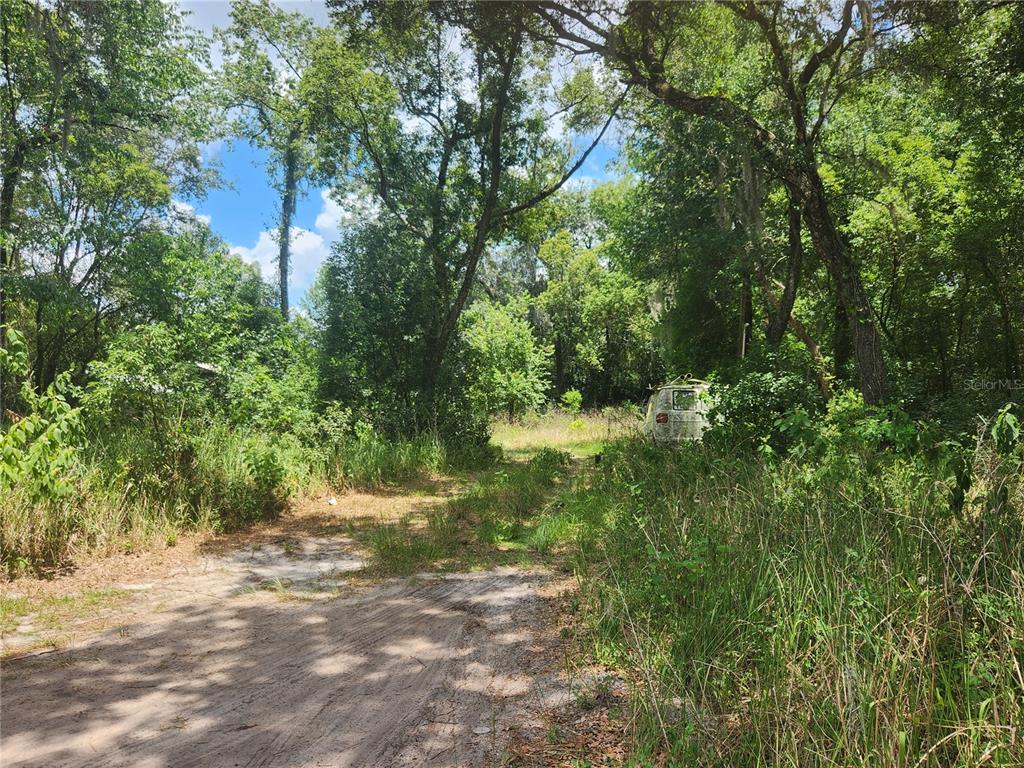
[0,423,485,574]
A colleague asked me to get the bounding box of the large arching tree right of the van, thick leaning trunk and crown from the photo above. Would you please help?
[531,0,892,403]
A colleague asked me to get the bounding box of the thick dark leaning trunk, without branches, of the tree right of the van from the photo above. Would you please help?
[804,171,889,406]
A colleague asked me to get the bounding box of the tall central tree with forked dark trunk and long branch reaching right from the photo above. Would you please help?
[333,2,614,421]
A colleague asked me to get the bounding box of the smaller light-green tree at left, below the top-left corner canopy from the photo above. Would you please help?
[11,131,202,391]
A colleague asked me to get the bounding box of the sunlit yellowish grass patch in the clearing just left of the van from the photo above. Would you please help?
[490,408,640,459]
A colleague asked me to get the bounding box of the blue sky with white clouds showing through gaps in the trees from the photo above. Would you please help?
[178,0,617,306]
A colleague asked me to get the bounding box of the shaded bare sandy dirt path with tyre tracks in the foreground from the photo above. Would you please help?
[0,539,565,767]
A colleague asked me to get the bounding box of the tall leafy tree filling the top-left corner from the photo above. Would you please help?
[0,0,202,346]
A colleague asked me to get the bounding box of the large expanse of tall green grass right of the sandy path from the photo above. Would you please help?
[542,442,1024,768]
